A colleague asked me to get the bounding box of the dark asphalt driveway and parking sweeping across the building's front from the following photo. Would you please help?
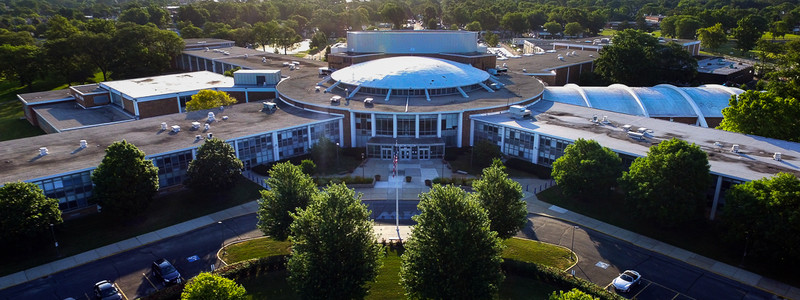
[0,201,775,300]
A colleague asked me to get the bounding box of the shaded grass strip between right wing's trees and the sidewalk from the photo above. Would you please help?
[537,186,800,286]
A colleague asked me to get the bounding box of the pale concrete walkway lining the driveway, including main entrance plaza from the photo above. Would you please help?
[0,159,800,299]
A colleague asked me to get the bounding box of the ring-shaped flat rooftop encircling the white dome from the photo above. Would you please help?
[277,60,544,113]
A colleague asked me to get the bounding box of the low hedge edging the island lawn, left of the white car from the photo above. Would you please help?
[501,259,624,300]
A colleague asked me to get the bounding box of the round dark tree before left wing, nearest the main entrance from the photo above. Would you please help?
[186,138,244,191]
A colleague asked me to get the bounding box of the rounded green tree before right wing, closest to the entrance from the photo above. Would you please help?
[552,139,622,198]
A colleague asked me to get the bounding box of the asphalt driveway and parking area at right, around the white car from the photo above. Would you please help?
[520,215,775,299]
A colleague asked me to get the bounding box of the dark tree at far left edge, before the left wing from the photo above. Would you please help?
[0,182,63,242]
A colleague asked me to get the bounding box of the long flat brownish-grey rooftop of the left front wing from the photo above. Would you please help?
[0,103,341,182]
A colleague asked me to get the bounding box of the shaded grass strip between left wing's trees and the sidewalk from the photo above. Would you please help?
[0,177,261,276]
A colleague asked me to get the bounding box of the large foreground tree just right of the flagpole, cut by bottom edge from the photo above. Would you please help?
[400,184,504,299]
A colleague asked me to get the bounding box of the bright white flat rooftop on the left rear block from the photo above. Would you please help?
[102,71,233,98]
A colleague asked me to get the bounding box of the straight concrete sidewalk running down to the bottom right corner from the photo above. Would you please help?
[523,189,800,299]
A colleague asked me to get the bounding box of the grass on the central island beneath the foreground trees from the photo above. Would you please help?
[225,238,574,299]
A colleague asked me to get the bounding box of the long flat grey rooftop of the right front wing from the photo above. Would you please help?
[473,100,800,180]
